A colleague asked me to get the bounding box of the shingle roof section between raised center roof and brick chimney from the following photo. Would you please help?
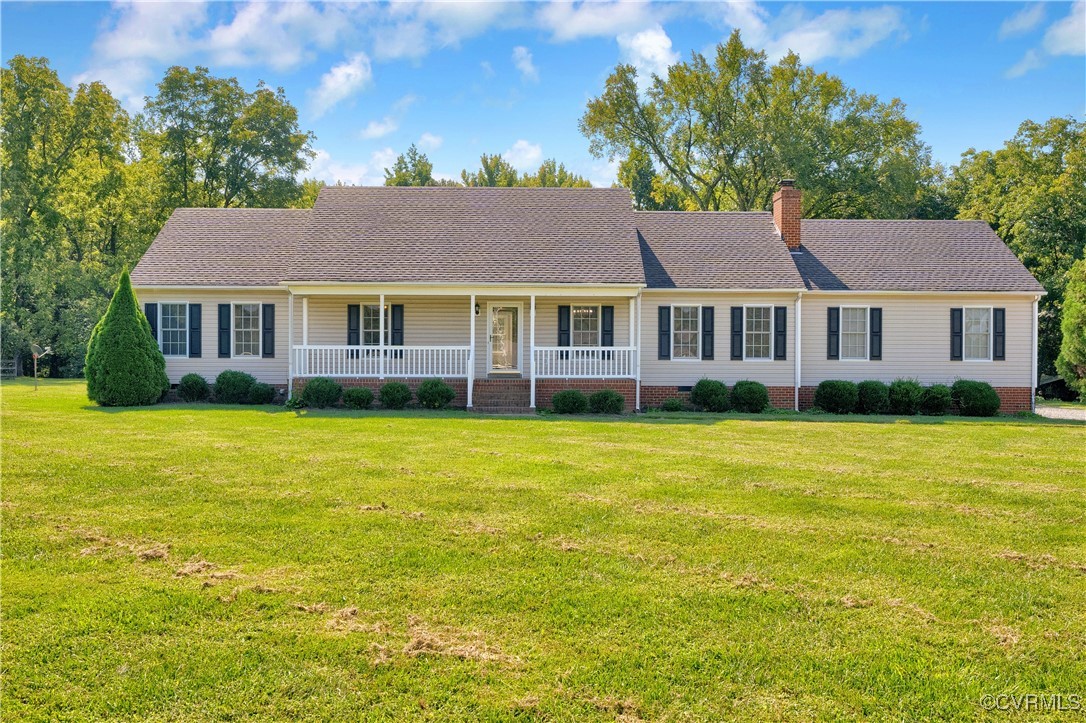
[633,211,804,289]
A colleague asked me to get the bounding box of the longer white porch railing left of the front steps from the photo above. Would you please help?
[294,345,471,377]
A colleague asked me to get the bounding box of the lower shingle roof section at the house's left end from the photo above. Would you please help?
[131,208,310,287]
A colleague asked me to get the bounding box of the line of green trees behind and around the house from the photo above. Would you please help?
[0,33,1086,376]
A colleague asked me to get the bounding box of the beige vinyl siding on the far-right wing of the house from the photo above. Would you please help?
[803,292,1033,386]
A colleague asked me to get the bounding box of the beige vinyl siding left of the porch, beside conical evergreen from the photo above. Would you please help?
[136,288,288,385]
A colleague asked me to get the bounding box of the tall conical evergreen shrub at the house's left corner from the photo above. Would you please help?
[84,271,169,407]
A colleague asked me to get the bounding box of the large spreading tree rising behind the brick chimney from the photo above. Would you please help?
[580,30,931,218]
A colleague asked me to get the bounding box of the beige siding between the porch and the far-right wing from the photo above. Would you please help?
[641,290,806,386]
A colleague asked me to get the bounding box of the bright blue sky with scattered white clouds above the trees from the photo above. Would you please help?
[0,0,1086,183]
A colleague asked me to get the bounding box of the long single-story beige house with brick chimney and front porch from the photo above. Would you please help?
[131,181,1044,411]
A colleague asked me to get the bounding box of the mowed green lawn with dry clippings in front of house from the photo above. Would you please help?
[0,382,1086,720]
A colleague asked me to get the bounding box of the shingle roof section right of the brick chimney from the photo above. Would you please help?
[793,219,1044,292]
